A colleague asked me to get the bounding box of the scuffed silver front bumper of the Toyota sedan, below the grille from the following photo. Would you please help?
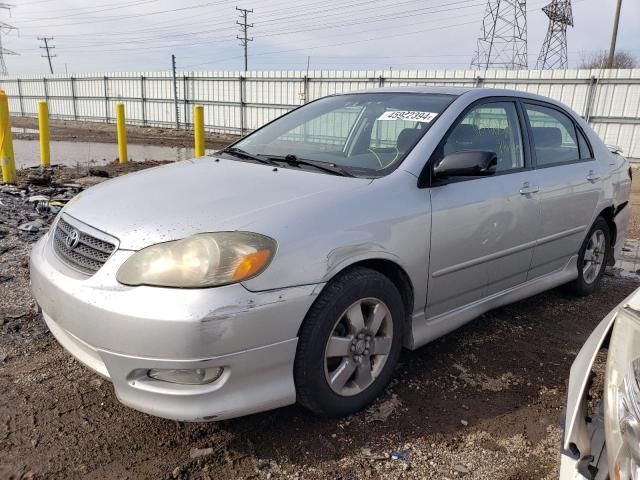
[30,230,322,420]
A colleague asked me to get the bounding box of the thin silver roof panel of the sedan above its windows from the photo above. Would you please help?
[336,86,568,110]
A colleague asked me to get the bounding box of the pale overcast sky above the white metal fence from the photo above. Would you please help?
[0,0,640,74]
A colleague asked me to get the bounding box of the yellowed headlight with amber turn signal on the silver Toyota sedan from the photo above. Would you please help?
[117,232,276,288]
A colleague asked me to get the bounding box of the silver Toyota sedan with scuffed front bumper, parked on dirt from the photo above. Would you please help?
[31,88,631,420]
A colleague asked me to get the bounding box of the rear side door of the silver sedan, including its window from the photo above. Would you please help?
[523,100,602,279]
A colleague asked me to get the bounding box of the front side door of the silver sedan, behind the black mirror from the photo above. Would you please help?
[427,99,540,319]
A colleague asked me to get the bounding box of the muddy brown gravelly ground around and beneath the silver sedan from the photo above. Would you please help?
[0,158,640,480]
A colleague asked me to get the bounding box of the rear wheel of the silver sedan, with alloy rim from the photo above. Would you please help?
[567,217,611,296]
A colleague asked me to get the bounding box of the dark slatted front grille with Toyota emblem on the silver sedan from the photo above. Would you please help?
[53,218,116,275]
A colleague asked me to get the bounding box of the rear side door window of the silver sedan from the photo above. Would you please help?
[525,103,590,166]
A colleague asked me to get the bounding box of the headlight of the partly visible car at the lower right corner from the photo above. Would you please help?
[605,309,640,480]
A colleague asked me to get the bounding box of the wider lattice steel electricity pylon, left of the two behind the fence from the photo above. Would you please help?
[471,0,528,70]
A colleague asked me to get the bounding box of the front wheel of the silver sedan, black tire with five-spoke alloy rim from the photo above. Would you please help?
[294,267,405,416]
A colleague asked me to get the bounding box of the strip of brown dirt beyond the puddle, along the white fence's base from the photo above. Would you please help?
[11,117,238,148]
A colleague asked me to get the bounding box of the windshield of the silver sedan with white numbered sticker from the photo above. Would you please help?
[233,93,454,175]
